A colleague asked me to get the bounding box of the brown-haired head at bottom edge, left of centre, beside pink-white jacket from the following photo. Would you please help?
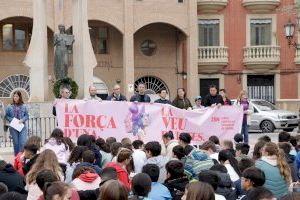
[98,180,128,200]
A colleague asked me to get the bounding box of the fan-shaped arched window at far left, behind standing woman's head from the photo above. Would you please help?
[0,74,30,98]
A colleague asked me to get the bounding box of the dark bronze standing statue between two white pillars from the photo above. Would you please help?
[54,24,74,80]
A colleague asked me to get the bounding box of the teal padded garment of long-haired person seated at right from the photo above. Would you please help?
[255,160,288,198]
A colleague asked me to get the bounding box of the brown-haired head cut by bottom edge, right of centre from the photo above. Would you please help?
[186,181,215,200]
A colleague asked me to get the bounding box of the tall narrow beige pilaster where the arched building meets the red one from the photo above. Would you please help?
[187,0,200,98]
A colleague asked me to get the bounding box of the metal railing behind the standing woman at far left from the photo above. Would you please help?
[0,117,57,147]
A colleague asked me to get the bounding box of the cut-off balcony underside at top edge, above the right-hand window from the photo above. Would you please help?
[243,0,280,13]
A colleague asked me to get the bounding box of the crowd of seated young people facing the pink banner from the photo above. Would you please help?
[0,129,300,200]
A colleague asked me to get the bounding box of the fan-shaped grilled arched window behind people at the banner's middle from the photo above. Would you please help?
[134,76,170,101]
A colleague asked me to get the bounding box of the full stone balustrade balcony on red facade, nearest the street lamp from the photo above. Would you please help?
[244,46,280,71]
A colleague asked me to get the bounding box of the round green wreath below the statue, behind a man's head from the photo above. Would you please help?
[53,77,78,99]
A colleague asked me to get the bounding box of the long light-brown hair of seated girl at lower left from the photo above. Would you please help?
[26,149,62,184]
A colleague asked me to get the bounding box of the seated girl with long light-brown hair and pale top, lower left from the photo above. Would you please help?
[26,149,64,200]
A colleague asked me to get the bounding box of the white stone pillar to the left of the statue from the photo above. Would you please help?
[23,0,48,102]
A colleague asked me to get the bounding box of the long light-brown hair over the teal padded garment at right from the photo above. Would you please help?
[264,142,291,182]
